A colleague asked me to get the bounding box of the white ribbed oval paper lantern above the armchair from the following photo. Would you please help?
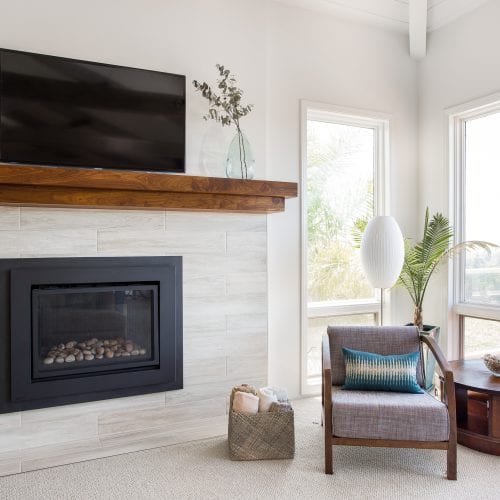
[361,215,405,288]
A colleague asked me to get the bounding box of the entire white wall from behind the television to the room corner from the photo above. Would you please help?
[0,0,417,395]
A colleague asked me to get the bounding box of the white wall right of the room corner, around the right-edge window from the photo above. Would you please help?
[418,1,500,352]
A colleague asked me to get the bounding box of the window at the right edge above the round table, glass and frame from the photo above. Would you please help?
[450,96,500,358]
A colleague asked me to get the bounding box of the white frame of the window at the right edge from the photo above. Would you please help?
[446,92,500,359]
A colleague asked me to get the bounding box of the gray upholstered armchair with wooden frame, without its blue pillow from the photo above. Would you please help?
[322,326,457,479]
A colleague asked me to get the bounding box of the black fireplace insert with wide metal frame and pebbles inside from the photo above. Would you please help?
[0,257,182,411]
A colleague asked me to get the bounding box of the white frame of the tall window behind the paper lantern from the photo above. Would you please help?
[300,100,390,395]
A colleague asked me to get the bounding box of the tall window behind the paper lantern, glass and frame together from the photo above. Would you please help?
[301,103,388,393]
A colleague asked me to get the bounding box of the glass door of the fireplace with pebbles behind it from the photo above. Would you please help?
[31,283,158,379]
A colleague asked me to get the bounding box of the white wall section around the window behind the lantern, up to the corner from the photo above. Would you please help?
[266,2,417,394]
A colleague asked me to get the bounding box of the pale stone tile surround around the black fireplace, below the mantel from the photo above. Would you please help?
[0,206,267,475]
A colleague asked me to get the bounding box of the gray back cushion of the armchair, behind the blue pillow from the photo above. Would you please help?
[328,326,424,386]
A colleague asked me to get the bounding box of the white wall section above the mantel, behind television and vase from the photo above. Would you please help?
[0,0,265,178]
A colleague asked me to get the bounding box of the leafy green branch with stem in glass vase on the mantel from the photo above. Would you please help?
[193,64,253,179]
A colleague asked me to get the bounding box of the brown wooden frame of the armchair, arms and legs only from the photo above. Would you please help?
[321,335,457,480]
